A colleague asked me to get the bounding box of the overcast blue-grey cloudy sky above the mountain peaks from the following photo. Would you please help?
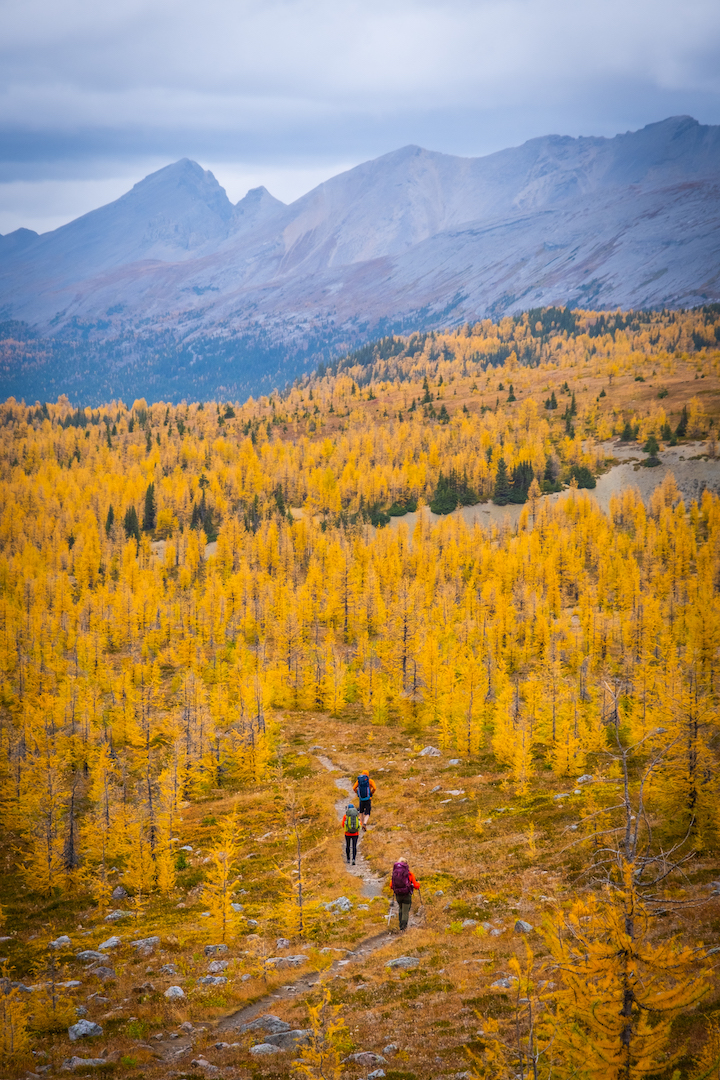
[0,0,720,233]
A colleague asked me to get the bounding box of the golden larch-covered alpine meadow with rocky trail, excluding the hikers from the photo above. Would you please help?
[0,303,720,1080]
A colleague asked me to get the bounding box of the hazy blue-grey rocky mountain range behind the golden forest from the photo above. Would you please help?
[0,117,720,401]
